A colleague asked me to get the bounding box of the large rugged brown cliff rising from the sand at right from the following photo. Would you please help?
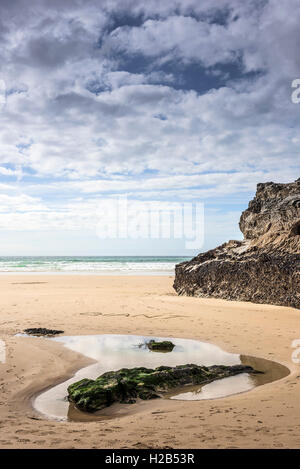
[174,178,300,308]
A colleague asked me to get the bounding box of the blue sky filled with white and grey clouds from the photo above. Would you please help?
[0,0,300,256]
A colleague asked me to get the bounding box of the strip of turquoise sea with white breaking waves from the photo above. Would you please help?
[0,256,190,275]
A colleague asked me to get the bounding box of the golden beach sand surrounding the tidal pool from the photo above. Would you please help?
[0,275,300,448]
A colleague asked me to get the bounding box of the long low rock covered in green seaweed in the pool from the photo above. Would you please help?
[68,364,259,412]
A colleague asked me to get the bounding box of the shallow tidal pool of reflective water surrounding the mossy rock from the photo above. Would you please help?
[24,335,289,420]
